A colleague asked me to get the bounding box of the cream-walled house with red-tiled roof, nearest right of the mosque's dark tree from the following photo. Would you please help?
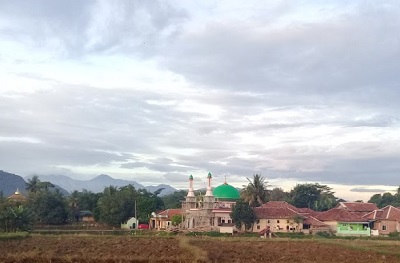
[253,201,304,232]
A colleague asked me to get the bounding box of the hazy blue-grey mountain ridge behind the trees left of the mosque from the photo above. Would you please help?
[29,174,176,196]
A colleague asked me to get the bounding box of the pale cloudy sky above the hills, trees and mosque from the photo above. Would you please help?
[0,0,400,201]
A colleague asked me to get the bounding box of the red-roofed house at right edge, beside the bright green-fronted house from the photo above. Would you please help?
[363,205,400,235]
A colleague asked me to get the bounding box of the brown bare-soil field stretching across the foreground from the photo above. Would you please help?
[0,235,400,263]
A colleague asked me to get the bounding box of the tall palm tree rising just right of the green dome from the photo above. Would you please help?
[240,174,269,207]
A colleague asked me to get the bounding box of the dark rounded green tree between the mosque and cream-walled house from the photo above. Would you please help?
[230,200,256,230]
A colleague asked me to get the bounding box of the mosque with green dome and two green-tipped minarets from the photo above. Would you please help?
[182,173,240,231]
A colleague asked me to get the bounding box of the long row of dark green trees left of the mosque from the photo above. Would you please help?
[0,176,165,232]
